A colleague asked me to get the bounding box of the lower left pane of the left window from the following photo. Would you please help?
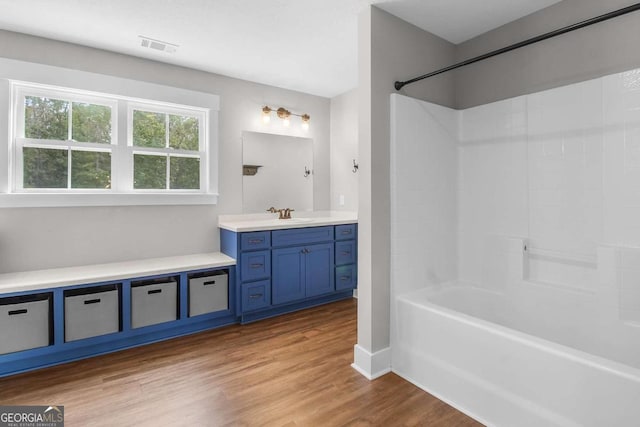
[22,147,68,188]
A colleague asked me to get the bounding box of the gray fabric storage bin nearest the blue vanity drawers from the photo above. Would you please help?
[189,271,229,317]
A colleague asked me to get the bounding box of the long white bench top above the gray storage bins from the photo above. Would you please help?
[0,252,236,293]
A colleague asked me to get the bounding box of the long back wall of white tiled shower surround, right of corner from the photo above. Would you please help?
[458,70,640,289]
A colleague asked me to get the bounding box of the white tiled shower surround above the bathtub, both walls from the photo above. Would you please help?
[391,70,640,301]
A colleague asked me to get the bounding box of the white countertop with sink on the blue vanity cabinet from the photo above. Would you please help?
[218,211,358,232]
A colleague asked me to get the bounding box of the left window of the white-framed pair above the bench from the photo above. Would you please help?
[14,88,117,191]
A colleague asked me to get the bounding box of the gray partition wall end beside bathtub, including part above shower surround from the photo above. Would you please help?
[358,7,455,353]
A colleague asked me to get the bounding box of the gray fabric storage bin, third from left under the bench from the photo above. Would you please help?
[131,280,178,329]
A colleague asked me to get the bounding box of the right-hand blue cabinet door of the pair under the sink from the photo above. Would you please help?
[305,243,335,297]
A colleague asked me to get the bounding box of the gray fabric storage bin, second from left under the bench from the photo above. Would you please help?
[64,285,120,342]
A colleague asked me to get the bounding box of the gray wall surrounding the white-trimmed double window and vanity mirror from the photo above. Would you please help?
[0,31,330,273]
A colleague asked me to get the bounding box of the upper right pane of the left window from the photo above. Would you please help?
[71,102,111,144]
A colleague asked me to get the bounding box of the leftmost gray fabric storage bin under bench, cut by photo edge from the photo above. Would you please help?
[0,293,52,354]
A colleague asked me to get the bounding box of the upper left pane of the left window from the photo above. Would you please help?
[24,96,69,141]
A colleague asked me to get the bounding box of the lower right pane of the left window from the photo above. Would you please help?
[71,150,111,188]
